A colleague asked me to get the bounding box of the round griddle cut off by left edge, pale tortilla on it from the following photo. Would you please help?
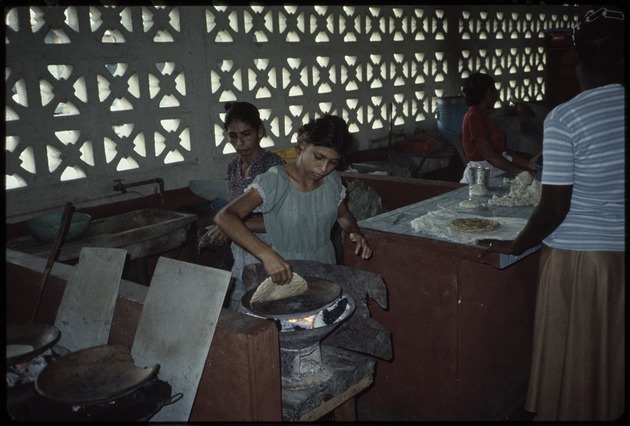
[7,324,61,365]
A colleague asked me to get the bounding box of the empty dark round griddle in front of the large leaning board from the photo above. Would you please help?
[35,345,160,405]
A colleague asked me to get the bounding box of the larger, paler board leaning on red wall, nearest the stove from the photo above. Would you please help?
[131,257,231,422]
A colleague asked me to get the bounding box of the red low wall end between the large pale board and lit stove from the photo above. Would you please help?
[189,309,282,423]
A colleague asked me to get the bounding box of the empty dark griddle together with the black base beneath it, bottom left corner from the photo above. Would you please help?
[7,345,183,422]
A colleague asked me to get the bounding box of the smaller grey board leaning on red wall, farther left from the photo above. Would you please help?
[55,247,127,352]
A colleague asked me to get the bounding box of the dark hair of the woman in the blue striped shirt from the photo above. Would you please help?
[573,7,625,73]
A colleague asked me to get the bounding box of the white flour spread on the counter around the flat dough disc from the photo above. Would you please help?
[411,209,527,245]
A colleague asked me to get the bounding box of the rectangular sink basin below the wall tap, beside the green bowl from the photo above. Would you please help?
[13,208,197,262]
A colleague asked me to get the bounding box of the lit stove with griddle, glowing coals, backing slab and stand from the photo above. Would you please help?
[240,260,392,421]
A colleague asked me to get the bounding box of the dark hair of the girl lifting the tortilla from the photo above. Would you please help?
[298,114,352,156]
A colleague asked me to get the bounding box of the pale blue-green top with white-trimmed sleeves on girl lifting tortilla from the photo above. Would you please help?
[251,167,346,264]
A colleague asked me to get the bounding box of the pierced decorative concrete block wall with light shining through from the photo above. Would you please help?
[5,4,579,218]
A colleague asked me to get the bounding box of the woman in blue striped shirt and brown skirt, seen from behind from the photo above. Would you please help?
[477,7,625,421]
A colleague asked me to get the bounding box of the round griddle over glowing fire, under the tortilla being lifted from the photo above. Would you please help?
[241,277,341,319]
